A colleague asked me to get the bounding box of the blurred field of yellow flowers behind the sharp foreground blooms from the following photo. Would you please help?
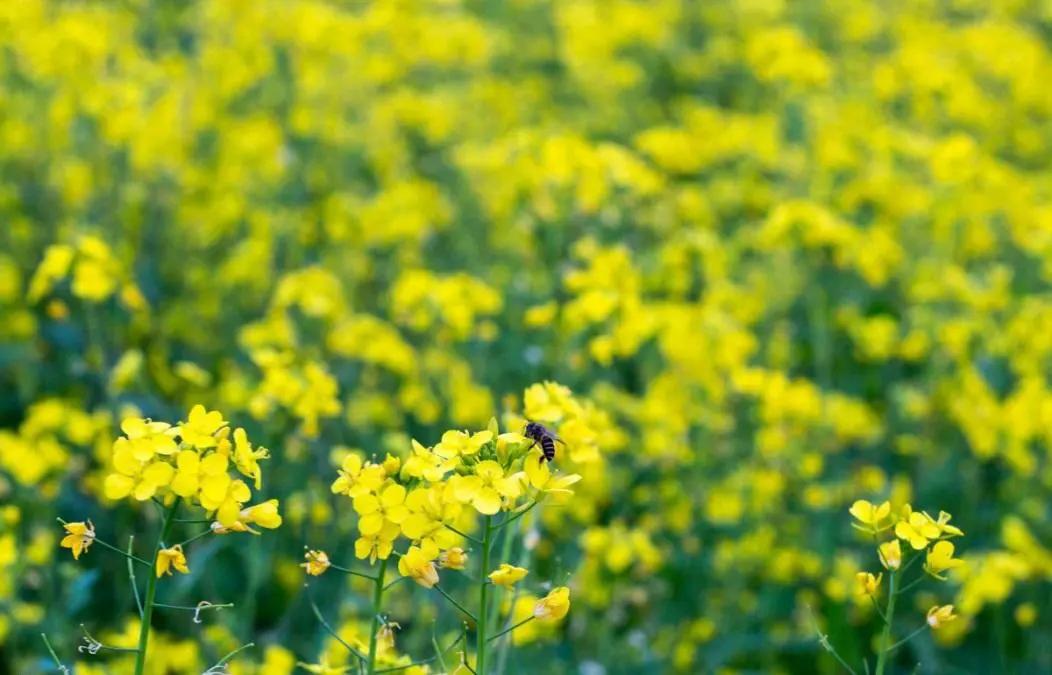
[0,0,1052,675]
